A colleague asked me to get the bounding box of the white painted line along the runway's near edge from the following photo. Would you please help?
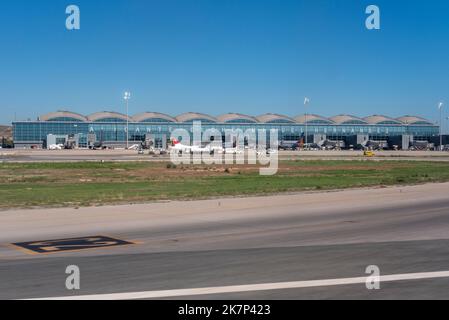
[29,271,449,300]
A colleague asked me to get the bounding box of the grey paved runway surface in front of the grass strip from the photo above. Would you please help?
[0,183,449,299]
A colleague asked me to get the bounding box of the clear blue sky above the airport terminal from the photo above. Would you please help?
[0,0,449,123]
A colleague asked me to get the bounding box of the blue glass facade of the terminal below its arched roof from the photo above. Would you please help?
[13,118,439,145]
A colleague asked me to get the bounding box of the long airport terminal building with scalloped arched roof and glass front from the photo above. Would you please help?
[13,111,439,149]
